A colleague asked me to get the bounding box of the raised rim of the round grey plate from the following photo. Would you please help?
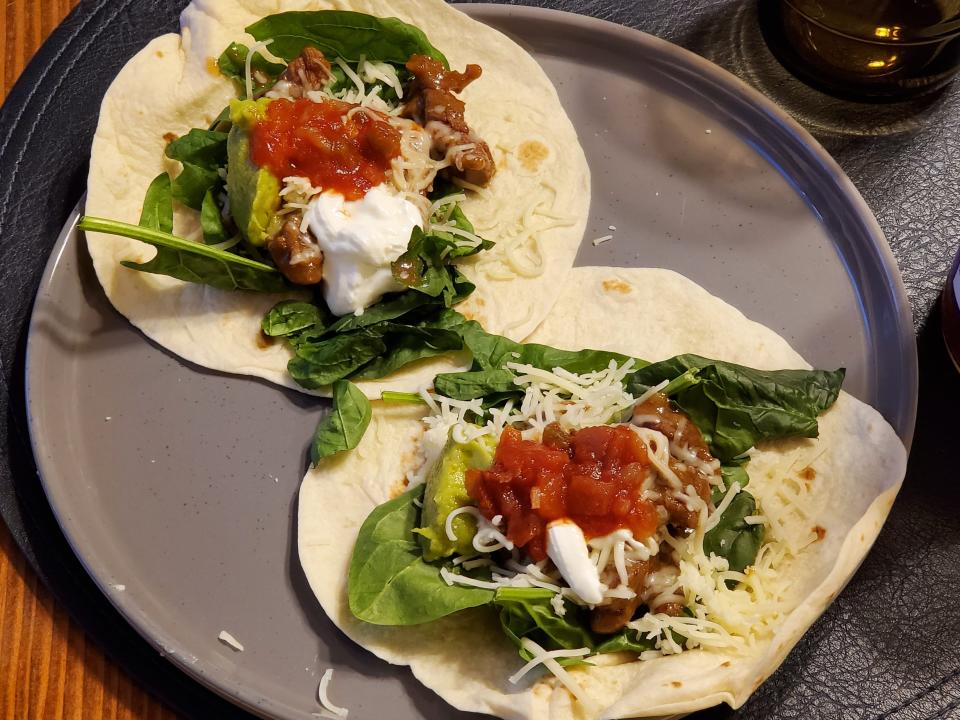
[23,3,919,718]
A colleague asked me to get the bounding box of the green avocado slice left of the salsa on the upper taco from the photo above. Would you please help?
[227,98,280,245]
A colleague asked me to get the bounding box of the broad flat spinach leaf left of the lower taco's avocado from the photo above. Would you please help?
[347,485,494,625]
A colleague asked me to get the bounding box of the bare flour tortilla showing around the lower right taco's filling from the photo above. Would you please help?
[298,268,906,720]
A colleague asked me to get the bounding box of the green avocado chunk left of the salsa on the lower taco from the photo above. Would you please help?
[414,436,497,561]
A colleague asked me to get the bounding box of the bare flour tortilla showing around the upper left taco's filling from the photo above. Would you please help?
[86,0,590,397]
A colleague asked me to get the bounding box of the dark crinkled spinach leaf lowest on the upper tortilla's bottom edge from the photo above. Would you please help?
[287,328,387,390]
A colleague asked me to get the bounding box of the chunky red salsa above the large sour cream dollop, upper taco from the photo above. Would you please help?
[250,98,400,200]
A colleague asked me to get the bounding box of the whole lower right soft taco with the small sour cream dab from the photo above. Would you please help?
[298,268,906,718]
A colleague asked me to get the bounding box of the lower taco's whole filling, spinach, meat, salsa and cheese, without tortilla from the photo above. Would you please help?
[348,336,843,709]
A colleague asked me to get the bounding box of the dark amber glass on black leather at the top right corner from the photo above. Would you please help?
[758,0,960,100]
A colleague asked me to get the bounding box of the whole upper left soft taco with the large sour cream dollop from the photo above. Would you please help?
[80,0,590,397]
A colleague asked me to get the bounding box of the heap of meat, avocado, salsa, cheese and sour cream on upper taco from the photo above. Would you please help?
[227,41,496,308]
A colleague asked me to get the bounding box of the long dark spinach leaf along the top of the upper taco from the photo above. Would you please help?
[246,10,450,68]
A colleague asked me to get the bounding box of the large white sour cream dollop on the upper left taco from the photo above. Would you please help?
[305,185,423,315]
